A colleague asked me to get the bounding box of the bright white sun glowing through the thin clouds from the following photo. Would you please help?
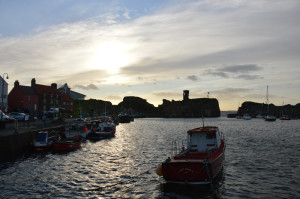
[91,42,132,74]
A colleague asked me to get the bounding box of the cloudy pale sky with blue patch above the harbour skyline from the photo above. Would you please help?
[0,0,300,111]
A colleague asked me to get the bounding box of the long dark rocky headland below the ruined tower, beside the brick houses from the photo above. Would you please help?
[74,96,220,117]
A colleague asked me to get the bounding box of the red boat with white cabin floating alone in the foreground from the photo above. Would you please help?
[156,126,225,184]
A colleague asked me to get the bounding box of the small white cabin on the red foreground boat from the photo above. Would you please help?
[187,126,221,152]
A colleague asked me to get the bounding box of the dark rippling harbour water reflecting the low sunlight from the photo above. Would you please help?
[0,117,300,199]
